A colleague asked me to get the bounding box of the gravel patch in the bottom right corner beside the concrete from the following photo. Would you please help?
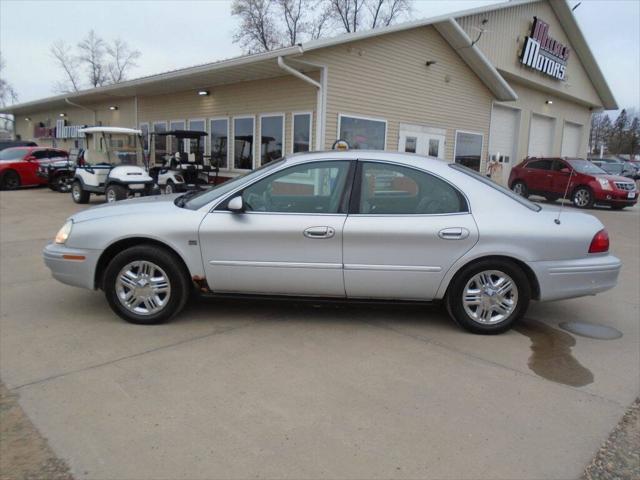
[583,398,640,480]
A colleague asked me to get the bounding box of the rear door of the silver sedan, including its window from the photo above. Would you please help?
[343,161,478,300]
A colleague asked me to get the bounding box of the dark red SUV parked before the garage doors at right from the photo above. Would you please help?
[509,158,638,210]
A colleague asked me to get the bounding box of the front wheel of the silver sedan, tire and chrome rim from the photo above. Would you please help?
[103,244,190,325]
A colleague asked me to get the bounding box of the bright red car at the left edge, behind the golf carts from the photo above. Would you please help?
[0,147,69,190]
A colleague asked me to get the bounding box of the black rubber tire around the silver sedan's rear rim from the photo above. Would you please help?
[445,259,531,335]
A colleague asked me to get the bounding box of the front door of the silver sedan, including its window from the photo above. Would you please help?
[199,161,355,297]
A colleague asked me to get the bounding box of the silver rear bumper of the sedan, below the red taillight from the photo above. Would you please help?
[529,255,622,301]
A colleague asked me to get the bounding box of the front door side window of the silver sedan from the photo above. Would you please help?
[242,161,349,213]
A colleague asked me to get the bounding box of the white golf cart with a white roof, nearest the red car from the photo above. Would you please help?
[71,127,158,203]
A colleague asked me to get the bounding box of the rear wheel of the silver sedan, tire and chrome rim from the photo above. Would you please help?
[446,259,531,335]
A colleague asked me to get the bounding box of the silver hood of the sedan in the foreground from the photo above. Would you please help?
[71,194,180,223]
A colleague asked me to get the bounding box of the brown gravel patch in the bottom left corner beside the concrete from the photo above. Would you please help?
[0,383,73,480]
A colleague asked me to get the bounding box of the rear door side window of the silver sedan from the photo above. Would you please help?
[356,162,468,215]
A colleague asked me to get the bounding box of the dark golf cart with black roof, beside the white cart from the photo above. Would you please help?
[149,130,218,194]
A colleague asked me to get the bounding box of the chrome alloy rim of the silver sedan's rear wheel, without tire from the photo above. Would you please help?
[462,270,518,325]
